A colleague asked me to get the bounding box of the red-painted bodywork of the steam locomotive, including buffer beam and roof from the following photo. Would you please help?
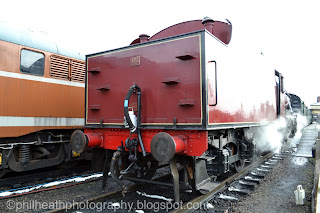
[85,20,284,156]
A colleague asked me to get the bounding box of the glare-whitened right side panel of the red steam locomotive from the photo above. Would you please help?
[205,31,277,125]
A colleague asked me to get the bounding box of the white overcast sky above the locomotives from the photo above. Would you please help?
[0,0,320,105]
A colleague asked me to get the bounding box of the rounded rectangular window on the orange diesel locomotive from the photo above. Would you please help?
[20,49,44,76]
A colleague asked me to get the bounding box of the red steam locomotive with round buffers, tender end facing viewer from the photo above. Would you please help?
[71,18,285,200]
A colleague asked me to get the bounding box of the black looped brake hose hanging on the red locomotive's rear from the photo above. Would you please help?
[123,84,146,156]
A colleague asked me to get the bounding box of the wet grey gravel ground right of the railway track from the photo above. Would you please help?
[229,125,318,213]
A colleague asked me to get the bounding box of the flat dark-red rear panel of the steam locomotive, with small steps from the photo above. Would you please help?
[86,35,202,125]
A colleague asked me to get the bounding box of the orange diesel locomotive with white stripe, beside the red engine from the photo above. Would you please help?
[0,22,85,176]
